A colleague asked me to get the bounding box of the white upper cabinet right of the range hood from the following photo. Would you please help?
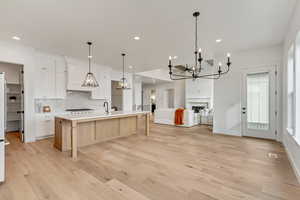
[92,66,111,101]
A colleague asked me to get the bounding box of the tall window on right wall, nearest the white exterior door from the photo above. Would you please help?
[287,45,295,135]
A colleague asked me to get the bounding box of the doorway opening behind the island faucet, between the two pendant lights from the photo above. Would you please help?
[111,81,123,111]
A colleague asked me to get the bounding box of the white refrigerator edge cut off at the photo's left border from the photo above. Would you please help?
[0,72,6,182]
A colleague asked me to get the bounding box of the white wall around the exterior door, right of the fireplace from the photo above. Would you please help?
[213,45,282,136]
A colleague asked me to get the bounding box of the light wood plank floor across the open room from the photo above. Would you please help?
[0,124,300,200]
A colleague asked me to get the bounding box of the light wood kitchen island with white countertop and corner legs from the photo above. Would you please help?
[54,111,150,160]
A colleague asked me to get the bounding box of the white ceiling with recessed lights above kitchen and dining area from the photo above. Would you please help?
[0,0,297,71]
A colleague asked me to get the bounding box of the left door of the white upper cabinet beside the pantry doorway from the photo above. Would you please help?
[35,54,55,98]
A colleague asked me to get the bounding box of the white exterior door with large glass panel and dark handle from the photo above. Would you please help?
[241,66,277,139]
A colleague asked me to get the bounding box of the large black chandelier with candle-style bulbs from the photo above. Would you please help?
[168,12,231,80]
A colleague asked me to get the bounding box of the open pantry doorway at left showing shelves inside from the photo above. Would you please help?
[0,62,25,142]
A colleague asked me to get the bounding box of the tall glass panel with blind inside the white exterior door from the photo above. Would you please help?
[247,72,269,130]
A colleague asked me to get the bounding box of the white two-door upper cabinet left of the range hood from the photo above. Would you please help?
[35,53,66,99]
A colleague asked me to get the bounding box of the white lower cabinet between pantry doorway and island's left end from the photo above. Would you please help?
[35,113,54,139]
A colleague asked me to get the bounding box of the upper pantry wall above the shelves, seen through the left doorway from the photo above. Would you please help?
[0,62,22,84]
